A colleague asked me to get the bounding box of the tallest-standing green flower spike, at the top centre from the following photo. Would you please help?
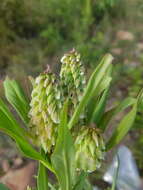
[60,50,85,108]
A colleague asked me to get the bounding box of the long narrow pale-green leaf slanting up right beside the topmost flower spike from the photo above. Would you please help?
[68,54,113,129]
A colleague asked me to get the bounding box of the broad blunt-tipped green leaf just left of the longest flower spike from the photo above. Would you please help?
[4,78,30,124]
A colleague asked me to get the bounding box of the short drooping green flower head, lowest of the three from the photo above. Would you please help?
[75,126,105,172]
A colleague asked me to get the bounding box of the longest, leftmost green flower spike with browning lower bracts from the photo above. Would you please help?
[29,67,61,153]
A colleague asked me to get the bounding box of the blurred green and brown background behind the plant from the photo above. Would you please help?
[0,0,143,190]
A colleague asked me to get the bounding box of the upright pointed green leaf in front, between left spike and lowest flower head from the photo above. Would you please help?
[51,102,75,190]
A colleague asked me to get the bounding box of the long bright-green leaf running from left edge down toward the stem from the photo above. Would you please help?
[0,99,54,171]
